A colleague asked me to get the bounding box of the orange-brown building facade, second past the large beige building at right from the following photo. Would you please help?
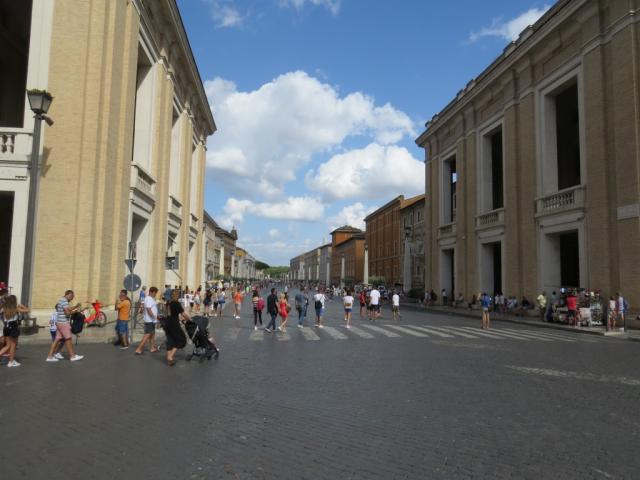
[364,195,404,287]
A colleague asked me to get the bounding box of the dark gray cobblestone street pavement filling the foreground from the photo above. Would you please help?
[0,290,640,480]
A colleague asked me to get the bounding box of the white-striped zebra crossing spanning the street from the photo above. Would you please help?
[238,323,597,343]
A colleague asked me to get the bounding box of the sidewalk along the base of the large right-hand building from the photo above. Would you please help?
[401,303,640,341]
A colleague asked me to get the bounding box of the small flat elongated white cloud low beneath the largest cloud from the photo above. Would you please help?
[220,197,324,227]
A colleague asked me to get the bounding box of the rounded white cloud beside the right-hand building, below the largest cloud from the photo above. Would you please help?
[306,143,424,200]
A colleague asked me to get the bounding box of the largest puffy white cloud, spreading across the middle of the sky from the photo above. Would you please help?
[205,71,416,200]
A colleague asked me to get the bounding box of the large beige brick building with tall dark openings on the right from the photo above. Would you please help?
[417,0,640,307]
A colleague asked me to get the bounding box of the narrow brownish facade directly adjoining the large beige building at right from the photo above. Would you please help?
[400,194,425,292]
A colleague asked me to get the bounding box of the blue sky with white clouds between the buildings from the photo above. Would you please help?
[178,0,553,265]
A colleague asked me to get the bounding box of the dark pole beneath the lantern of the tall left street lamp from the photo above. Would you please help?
[21,114,42,306]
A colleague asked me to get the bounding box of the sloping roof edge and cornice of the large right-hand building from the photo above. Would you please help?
[415,0,575,147]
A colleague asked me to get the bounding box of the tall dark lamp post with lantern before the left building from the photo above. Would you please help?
[21,90,53,305]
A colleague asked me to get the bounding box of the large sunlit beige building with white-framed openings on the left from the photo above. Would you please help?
[0,0,216,308]
